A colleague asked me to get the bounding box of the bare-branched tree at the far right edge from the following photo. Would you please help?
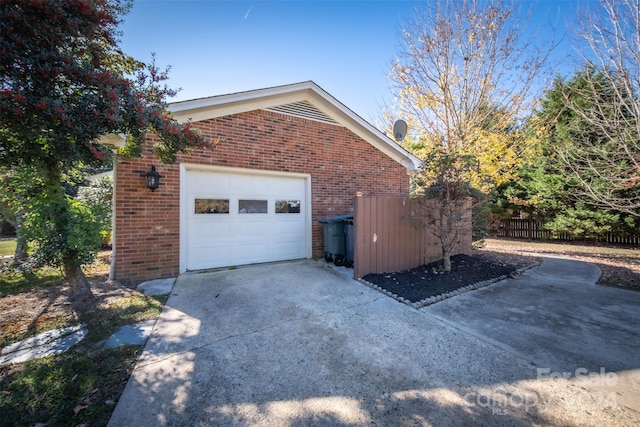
[558,0,640,216]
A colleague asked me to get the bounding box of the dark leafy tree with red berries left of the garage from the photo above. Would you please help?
[0,0,215,301]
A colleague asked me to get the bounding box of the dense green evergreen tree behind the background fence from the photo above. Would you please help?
[494,70,635,238]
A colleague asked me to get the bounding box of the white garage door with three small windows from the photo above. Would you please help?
[181,166,311,272]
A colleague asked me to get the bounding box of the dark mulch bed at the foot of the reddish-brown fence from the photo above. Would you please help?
[363,255,519,303]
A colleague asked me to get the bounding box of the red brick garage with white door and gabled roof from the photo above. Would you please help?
[111,81,420,282]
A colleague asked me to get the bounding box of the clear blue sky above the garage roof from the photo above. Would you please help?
[120,0,592,123]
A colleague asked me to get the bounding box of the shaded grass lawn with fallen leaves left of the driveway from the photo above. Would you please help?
[0,253,167,426]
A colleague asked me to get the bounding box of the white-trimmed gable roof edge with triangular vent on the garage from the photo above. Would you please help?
[169,81,420,172]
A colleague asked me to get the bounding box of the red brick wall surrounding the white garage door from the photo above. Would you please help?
[115,110,409,282]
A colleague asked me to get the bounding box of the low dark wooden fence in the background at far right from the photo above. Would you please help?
[495,218,640,245]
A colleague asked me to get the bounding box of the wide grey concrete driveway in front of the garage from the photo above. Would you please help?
[109,259,640,426]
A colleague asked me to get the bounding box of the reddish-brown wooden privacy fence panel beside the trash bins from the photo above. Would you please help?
[354,197,472,278]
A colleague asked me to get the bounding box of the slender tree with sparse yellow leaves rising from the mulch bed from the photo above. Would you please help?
[391,0,553,270]
